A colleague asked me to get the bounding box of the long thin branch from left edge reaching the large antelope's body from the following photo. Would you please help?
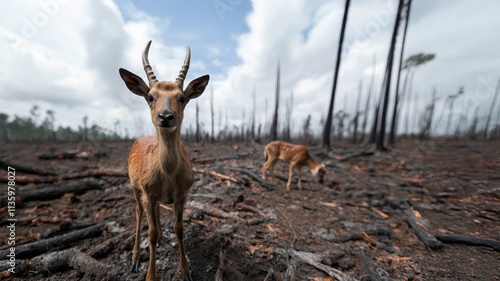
[0,168,128,184]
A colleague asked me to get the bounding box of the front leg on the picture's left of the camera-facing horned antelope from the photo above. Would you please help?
[144,198,160,281]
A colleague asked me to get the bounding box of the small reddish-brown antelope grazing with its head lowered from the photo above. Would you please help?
[262,141,326,191]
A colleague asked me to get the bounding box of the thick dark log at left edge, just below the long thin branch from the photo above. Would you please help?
[0,177,102,206]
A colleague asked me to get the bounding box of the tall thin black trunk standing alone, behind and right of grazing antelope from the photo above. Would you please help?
[323,0,351,150]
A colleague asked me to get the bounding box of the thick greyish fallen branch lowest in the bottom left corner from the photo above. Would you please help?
[2,248,122,280]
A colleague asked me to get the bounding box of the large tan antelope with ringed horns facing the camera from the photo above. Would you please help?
[119,41,210,281]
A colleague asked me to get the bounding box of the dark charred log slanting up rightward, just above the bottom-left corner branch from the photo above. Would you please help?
[0,224,104,259]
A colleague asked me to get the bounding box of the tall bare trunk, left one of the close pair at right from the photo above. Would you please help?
[376,0,404,150]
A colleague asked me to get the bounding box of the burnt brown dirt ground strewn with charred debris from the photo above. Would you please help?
[0,140,500,281]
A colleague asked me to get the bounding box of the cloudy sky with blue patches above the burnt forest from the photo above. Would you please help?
[0,0,500,135]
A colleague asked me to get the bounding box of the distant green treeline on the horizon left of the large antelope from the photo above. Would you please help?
[0,105,124,142]
